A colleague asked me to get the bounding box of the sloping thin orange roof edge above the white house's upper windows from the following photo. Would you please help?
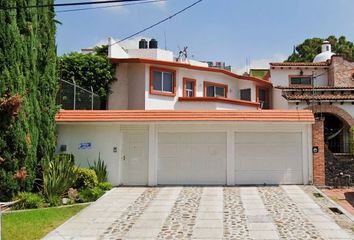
[110,58,272,87]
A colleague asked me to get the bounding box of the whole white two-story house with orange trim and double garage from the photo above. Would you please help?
[56,40,314,185]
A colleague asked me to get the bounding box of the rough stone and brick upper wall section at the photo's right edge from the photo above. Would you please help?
[328,56,354,87]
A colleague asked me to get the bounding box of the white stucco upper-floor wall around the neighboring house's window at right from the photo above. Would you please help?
[270,67,328,86]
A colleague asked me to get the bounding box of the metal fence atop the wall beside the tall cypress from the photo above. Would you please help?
[57,79,101,110]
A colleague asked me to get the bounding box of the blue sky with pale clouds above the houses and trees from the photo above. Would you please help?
[55,0,354,72]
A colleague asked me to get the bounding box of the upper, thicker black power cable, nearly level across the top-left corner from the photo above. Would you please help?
[0,0,148,10]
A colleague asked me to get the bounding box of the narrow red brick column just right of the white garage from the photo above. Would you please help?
[312,120,326,186]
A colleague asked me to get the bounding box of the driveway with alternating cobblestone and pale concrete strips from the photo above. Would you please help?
[45,186,354,240]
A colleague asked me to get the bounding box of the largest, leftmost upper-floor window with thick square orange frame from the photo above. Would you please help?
[150,67,176,96]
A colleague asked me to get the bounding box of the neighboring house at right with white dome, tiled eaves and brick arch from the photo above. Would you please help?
[270,41,354,154]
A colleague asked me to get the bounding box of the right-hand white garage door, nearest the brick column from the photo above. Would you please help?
[235,132,303,184]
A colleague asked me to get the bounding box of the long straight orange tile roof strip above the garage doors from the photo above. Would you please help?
[55,110,314,123]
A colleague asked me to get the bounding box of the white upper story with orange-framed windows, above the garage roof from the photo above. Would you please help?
[108,40,272,110]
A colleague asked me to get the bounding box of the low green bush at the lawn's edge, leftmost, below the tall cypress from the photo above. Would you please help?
[13,192,45,209]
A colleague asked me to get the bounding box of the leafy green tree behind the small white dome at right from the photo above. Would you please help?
[286,36,354,62]
